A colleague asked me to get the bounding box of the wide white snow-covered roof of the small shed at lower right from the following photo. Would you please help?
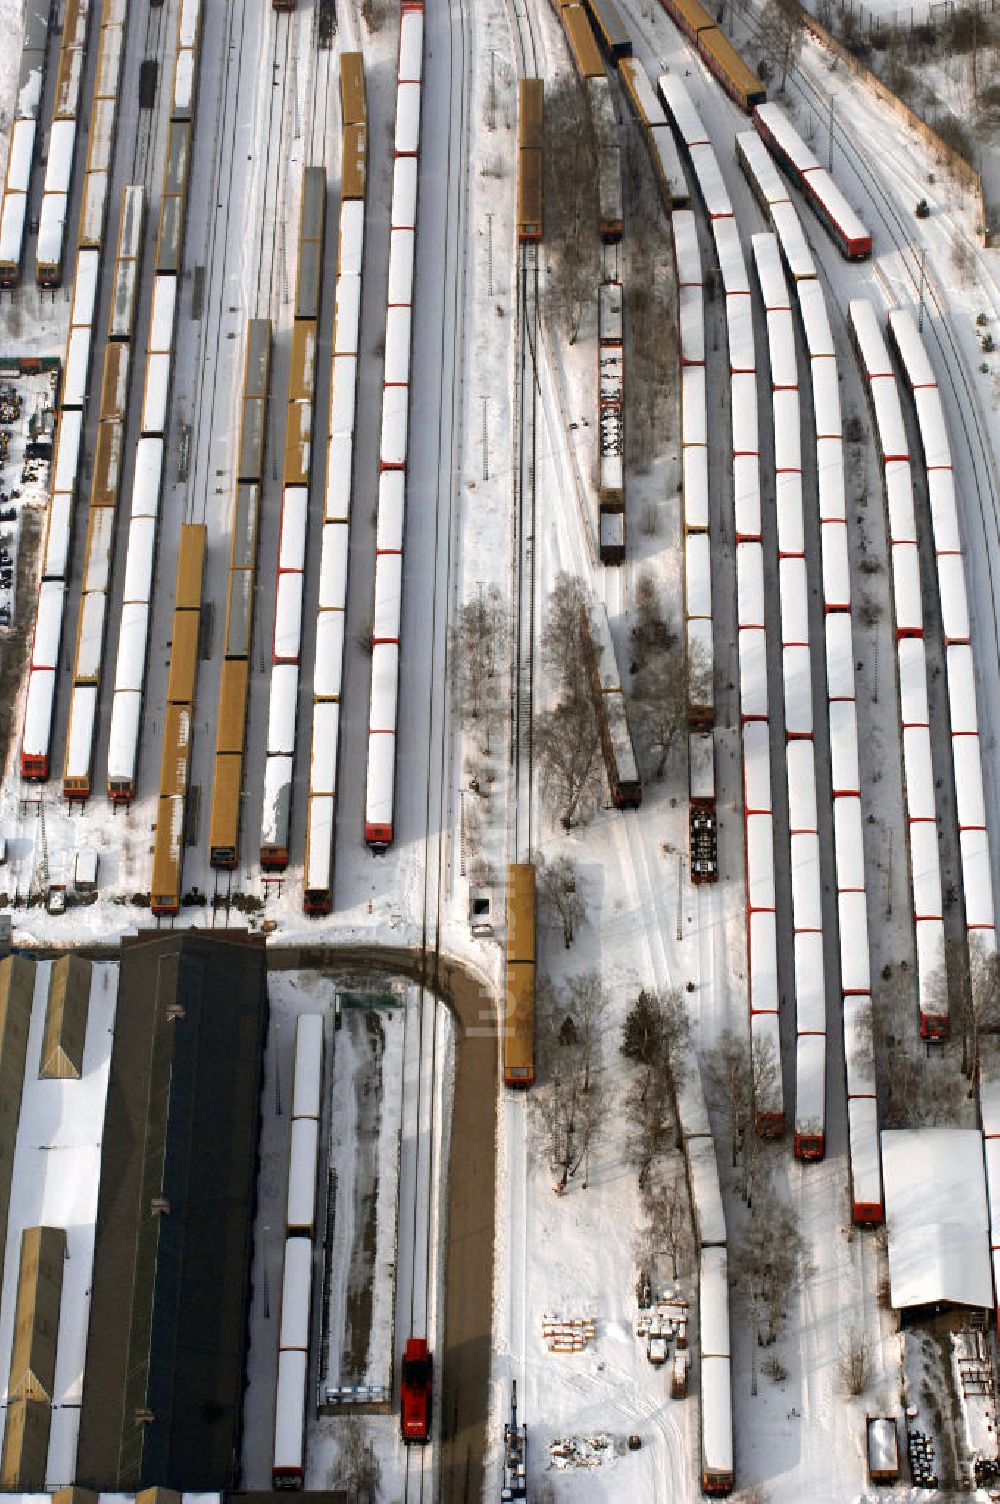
[881,1128,992,1310]
